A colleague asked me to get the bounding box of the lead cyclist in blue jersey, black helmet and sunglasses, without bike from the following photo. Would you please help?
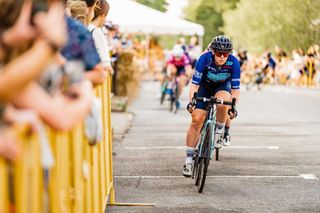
[182,35,240,177]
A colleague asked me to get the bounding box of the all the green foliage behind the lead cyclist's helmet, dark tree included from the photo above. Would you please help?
[184,0,320,52]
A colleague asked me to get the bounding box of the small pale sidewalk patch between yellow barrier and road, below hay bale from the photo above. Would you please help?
[111,112,134,141]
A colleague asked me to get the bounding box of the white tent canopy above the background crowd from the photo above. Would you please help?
[107,0,204,36]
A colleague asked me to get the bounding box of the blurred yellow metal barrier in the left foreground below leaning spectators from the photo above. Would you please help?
[0,74,115,213]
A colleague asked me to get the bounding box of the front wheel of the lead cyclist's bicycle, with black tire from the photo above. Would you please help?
[198,125,212,193]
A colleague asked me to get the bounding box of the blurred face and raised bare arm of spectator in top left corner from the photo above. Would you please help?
[0,0,66,102]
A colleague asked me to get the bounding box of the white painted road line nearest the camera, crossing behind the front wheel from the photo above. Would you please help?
[114,175,308,179]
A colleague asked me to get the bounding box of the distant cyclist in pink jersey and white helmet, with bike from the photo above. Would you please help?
[167,45,192,108]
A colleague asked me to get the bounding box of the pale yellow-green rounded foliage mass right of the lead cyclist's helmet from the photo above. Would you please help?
[223,0,320,52]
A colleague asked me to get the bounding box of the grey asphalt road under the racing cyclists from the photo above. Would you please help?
[107,81,320,213]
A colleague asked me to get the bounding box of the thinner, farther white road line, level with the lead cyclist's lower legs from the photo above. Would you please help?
[124,146,279,150]
